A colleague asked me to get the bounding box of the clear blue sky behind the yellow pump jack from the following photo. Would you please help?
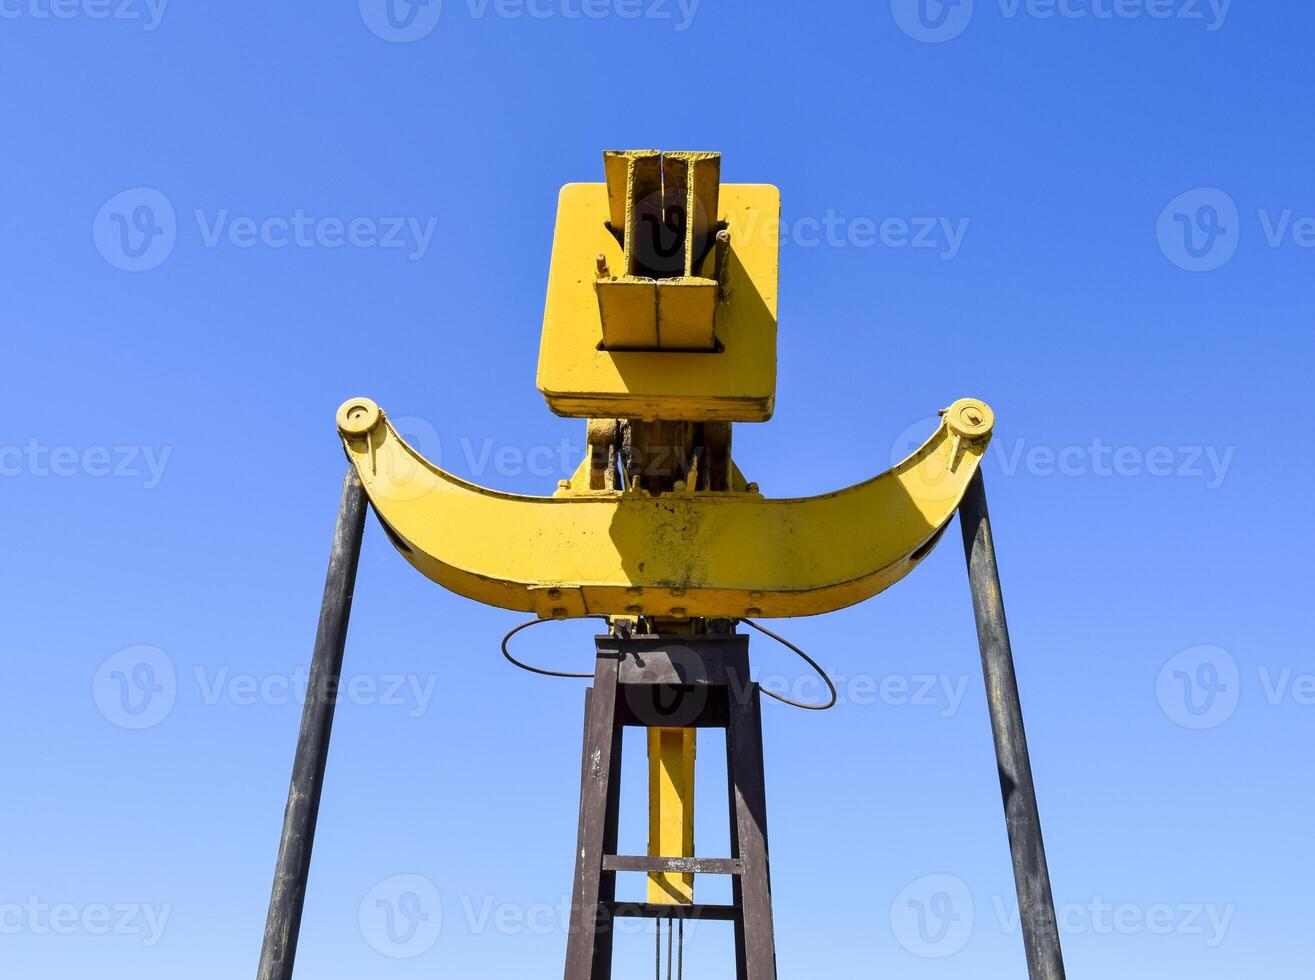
[0,0,1315,980]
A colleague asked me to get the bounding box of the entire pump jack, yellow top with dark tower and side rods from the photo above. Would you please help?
[259,150,1064,980]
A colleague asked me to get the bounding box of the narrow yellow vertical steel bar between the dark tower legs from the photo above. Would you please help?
[648,729,697,905]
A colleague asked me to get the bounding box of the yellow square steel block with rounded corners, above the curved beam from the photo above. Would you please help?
[538,176,781,422]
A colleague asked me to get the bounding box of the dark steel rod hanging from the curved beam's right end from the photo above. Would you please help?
[959,472,1064,980]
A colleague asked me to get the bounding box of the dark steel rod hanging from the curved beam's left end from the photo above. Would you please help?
[256,470,366,980]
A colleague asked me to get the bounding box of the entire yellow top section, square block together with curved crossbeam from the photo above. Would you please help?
[338,150,993,620]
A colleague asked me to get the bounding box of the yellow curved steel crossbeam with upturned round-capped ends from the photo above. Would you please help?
[338,399,994,617]
